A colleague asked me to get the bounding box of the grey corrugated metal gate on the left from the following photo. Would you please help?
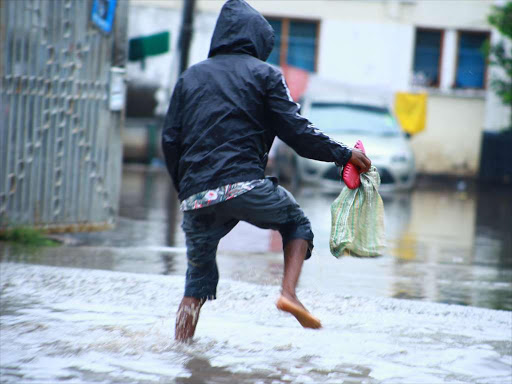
[0,0,127,230]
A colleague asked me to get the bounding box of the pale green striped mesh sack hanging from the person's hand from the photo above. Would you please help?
[329,166,385,257]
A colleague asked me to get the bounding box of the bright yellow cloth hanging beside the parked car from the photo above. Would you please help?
[395,92,427,135]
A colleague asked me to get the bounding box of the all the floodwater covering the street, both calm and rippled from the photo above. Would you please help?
[0,169,512,383]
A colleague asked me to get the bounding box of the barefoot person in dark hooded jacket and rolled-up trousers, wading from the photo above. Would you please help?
[162,0,370,341]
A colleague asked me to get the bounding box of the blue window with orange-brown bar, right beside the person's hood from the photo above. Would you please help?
[267,18,319,72]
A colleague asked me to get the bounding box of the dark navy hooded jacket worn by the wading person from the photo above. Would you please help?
[162,0,351,200]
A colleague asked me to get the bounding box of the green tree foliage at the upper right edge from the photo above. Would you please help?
[488,1,512,129]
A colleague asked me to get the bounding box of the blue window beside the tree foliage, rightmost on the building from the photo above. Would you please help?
[455,32,489,88]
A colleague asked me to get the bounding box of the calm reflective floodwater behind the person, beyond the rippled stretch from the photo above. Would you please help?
[0,168,512,310]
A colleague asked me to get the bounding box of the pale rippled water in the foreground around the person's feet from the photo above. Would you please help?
[0,263,512,383]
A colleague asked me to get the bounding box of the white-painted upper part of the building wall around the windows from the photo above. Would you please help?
[129,0,496,90]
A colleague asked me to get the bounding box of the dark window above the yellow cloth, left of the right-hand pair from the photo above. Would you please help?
[413,28,443,87]
